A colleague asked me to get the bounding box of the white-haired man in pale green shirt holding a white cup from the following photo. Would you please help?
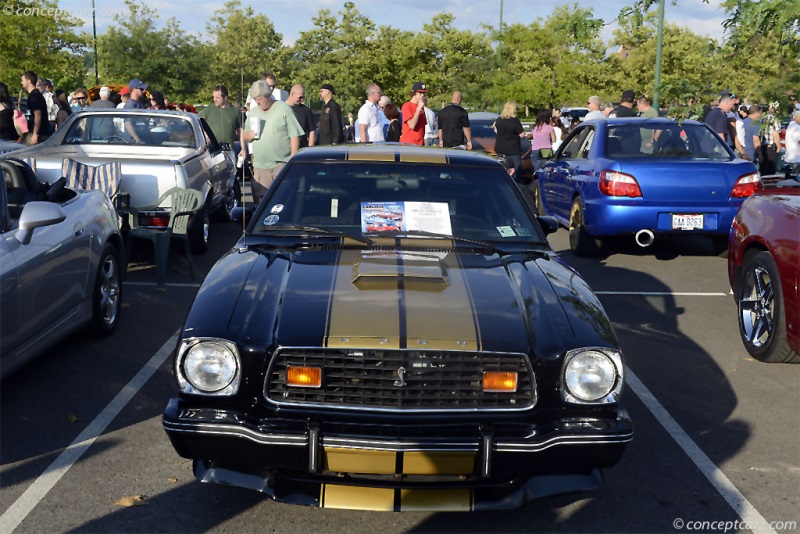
[240,80,305,204]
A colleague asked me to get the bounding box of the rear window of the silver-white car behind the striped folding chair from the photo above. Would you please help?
[63,113,197,148]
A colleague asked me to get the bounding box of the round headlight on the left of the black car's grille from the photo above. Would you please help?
[175,338,241,396]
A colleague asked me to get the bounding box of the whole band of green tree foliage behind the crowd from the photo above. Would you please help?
[0,0,800,115]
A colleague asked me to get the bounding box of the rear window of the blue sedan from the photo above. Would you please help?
[605,123,732,161]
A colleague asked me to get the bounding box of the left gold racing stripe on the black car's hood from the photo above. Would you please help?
[324,249,400,349]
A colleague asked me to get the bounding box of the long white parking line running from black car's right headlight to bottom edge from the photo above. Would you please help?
[625,368,775,534]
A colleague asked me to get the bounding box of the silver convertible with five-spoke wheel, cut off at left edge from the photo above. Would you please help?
[0,159,123,377]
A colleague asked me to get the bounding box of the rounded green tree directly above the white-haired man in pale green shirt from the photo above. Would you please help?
[204,0,288,100]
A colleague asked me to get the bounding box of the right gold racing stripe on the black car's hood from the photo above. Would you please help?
[404,250,481,351]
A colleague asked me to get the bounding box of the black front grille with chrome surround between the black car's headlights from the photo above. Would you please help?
[264,348,536,412]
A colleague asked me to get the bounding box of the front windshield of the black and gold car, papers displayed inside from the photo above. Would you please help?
[252,162,542,243]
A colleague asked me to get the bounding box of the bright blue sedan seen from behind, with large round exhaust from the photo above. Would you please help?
[532,118,762,256]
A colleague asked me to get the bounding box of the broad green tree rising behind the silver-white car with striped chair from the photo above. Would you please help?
[97,0,208,101]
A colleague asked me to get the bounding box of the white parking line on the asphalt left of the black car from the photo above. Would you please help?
[0,332,179,532]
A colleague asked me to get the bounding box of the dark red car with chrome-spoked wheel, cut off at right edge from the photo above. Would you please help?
[728,180,800,363]
